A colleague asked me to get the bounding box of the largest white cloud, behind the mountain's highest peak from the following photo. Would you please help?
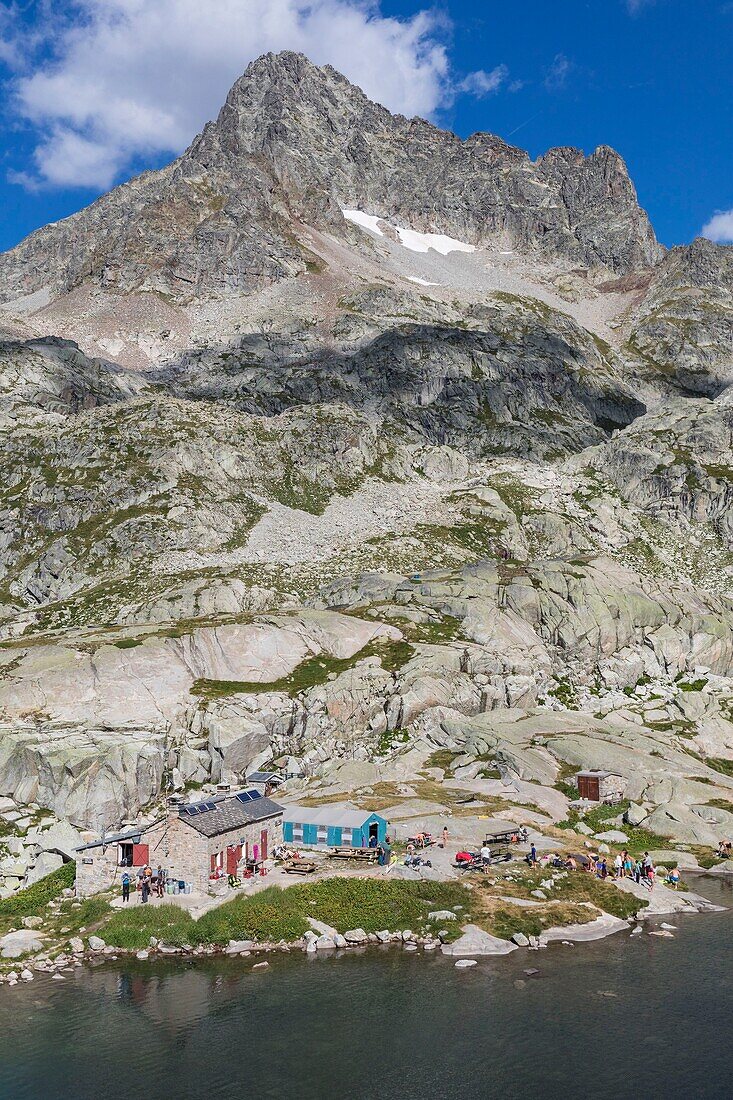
[5,0,464,189]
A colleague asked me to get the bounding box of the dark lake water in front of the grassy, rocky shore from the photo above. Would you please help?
[0,879,733,1100]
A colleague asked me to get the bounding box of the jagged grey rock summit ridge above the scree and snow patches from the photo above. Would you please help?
[0,53,663,301]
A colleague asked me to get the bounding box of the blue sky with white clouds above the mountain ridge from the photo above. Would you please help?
[0,0,733,249]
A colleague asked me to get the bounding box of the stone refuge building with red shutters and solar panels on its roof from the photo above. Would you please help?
[76,790,283,897]
